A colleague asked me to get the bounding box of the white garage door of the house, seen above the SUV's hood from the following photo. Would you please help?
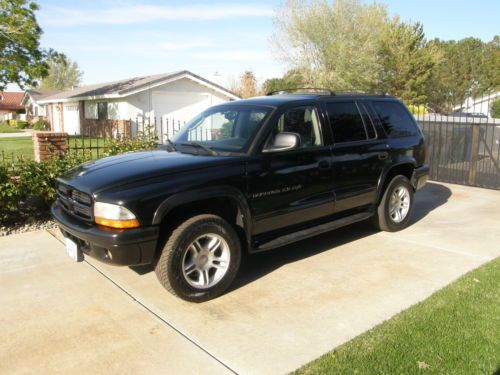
[153,92,210,137]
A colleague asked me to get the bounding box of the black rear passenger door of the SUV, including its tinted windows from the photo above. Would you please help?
[324,100,390,212]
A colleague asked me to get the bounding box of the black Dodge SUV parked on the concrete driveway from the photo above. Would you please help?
[52,93,428,301]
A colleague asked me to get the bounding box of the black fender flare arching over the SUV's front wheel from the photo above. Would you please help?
[152,185,252,244]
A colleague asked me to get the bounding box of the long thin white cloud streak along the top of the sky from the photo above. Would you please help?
[39,3,274,27]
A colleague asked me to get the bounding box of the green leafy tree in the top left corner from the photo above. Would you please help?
[0,0,48,91]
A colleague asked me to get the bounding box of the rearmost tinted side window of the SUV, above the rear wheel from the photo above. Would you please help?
[373,101,417,138]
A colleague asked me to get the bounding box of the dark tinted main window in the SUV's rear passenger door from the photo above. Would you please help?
[326,102,366,143]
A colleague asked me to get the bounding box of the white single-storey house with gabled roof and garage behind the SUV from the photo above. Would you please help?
[38,71,239,136]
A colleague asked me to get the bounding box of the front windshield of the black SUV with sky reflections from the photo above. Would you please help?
[172,106,271,152]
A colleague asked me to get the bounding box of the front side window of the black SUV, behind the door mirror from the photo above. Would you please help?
[266,106,323,148]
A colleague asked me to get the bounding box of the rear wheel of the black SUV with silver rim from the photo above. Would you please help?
[373,175,414,232]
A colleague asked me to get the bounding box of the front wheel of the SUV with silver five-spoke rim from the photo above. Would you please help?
[155,214,241,302]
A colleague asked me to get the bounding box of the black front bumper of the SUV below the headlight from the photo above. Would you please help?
[51,201,159,266]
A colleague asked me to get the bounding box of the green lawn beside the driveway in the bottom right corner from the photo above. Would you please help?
[295,258,500,375]
